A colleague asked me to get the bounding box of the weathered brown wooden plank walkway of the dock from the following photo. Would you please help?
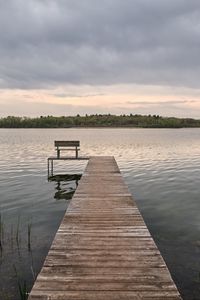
[28,157,181,300]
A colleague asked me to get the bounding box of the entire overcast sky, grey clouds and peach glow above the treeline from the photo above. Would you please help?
[0,0,200,118]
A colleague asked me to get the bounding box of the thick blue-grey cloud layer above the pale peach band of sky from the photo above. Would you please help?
[0,0,200,89]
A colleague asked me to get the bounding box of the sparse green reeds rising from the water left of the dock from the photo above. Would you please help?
[0,212,35,300]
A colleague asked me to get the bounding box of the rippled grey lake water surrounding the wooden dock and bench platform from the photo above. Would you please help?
[0,129,200,300]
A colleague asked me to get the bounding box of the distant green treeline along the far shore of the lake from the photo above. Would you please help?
[0,114,200,128]
